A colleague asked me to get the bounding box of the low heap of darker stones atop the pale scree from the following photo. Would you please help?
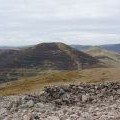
[42,82,120,105]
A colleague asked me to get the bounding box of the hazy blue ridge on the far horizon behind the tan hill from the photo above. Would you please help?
[71,44,120,52]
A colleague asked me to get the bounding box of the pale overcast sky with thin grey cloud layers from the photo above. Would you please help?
[0,0,120,46]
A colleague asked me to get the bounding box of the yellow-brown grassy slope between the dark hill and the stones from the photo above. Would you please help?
[0,68,120,95]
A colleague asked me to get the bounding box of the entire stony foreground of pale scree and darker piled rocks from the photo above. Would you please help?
[0,82,120,120]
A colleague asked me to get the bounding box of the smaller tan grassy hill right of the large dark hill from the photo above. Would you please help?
[86,46,120,67]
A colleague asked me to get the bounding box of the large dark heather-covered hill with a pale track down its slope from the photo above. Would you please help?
[0,43,99,70]
